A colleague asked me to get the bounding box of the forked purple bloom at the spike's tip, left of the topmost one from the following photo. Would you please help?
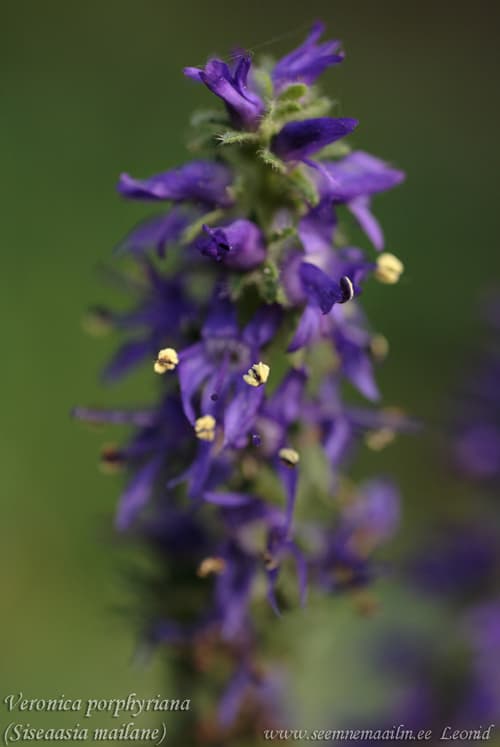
[184,54,264,130]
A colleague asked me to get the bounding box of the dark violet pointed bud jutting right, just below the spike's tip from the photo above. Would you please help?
[271,117,358,162]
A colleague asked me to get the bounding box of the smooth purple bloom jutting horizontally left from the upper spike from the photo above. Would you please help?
[118,161,232,207]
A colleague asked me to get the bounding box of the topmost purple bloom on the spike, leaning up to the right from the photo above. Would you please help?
[272,22,344,91]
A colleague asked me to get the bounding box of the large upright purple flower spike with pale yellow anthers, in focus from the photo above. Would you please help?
[74,22,408,745]
